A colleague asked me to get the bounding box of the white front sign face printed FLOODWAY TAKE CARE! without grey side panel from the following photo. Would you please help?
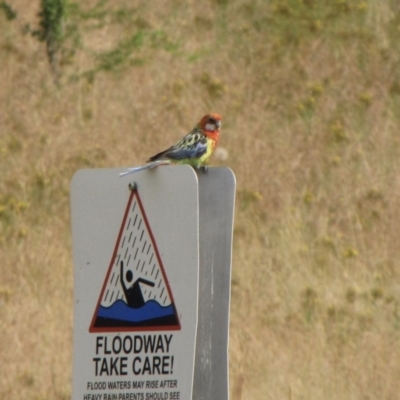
[71,166,199,400]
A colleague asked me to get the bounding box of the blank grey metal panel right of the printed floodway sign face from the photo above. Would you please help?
[193,168,236,400]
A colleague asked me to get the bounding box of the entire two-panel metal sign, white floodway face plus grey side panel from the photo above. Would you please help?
[71,166,235,400]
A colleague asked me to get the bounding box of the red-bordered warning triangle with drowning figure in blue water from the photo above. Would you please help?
[89,190,181,332]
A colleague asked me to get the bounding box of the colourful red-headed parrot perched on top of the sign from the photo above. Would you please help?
[119,113,222,177]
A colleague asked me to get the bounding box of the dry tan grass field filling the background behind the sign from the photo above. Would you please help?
[0,0,400,400]
